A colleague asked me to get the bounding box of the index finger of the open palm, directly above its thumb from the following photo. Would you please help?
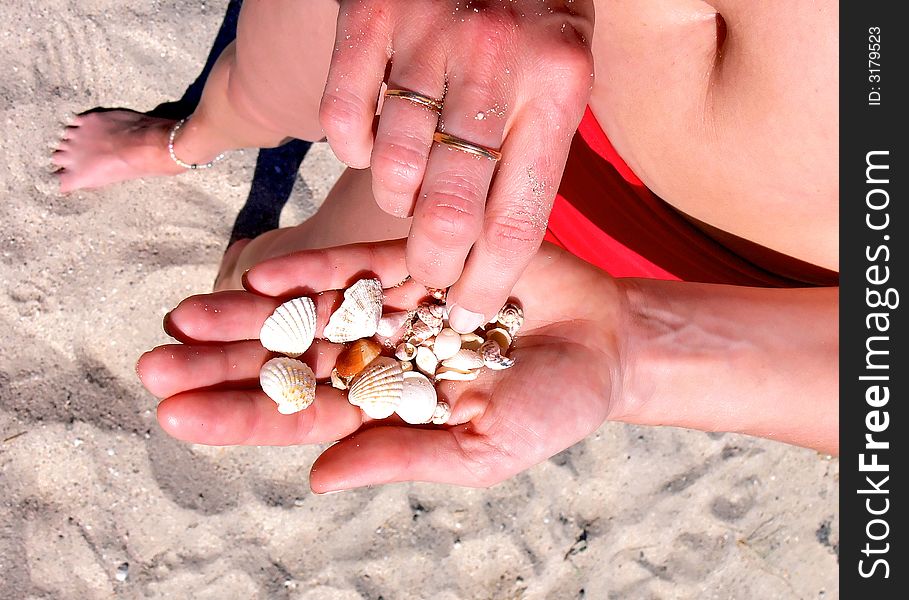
[158,385,363,446]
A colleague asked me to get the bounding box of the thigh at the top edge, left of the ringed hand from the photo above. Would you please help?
[229,0,338,140]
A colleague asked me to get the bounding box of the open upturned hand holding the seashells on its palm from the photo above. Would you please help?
[137,241,622,493]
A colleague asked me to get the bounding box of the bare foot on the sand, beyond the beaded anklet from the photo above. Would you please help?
[51,110,184,193]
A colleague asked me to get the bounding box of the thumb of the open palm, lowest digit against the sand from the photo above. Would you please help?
[309,425,520,494]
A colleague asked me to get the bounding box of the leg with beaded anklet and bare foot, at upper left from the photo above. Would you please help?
[53,0,337,192]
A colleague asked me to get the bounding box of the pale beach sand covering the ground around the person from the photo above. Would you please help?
[0,0,839,600]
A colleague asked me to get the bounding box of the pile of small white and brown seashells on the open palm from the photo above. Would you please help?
[259,279,524,425]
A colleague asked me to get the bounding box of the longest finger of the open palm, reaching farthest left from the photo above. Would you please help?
[136,340,341,398]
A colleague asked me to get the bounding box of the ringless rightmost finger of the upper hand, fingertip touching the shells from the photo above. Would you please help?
[448,107,580,332]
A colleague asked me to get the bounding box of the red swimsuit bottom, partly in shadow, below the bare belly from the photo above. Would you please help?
[546,108,836,287]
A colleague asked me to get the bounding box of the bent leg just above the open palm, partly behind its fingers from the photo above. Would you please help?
[214,169,410,291]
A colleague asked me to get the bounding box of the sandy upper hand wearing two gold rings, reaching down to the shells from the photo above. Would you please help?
[320,0,594,332]
